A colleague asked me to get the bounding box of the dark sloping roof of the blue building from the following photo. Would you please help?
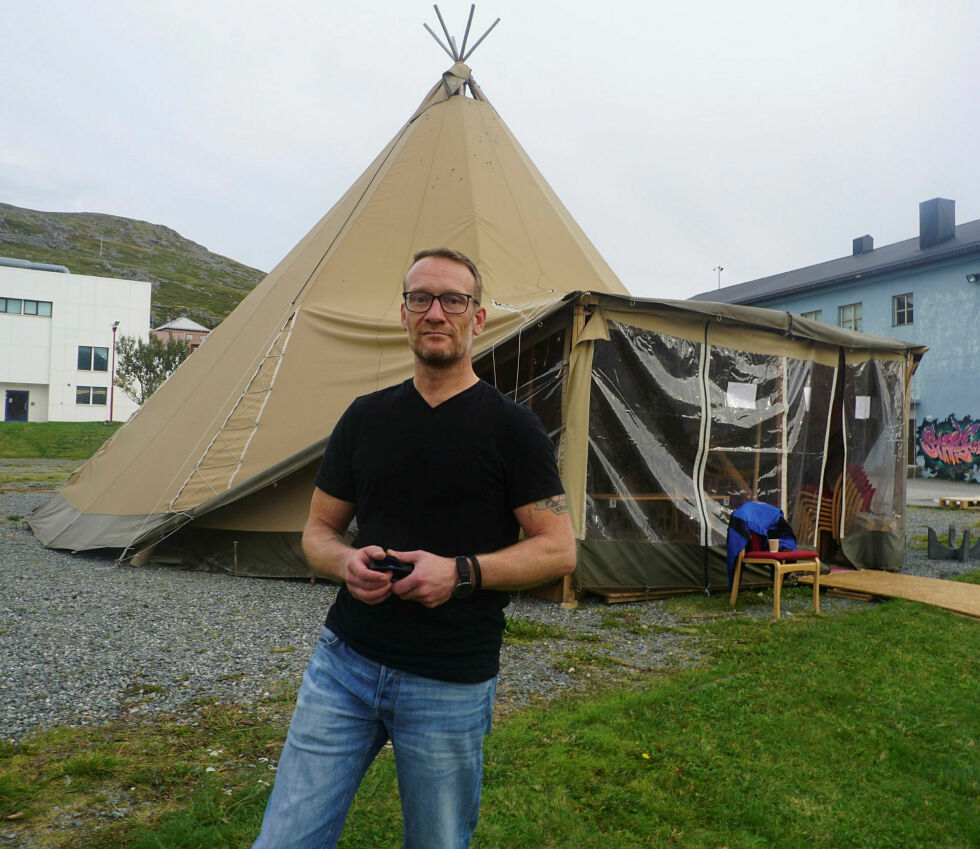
[690,215,980,304]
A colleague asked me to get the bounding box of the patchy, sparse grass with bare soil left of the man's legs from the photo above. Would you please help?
[0,690,295,849]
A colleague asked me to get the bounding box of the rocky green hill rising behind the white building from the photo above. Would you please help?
[0,203,265,327]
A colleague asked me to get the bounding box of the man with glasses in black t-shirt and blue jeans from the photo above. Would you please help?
[255,248,575,849]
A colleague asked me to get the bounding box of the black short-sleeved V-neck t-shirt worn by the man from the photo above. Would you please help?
[316,380,564,683]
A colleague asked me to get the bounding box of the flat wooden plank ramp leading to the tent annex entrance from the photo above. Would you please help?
[799,569,980,619]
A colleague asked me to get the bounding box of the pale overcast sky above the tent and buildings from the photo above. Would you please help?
[0,0,980,298]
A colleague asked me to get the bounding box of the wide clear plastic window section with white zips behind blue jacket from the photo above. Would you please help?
[586,322,835,545]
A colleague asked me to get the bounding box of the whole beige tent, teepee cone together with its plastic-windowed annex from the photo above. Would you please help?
[29,63,924,598]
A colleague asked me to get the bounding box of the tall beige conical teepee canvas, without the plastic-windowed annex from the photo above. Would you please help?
[30,56,626,574]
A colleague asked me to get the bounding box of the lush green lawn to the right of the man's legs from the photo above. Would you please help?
[477,603,980,849]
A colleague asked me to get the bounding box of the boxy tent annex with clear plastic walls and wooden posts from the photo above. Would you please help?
[468,293,926,601]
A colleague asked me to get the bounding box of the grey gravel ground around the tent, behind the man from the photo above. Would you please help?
[0,491,980,740]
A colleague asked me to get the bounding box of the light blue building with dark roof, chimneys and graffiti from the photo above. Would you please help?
[692,198,980,483]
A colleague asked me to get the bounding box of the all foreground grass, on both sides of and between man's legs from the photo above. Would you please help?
[0,584,980,849]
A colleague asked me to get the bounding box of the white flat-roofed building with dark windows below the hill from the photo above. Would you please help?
[0,260,151,422]
